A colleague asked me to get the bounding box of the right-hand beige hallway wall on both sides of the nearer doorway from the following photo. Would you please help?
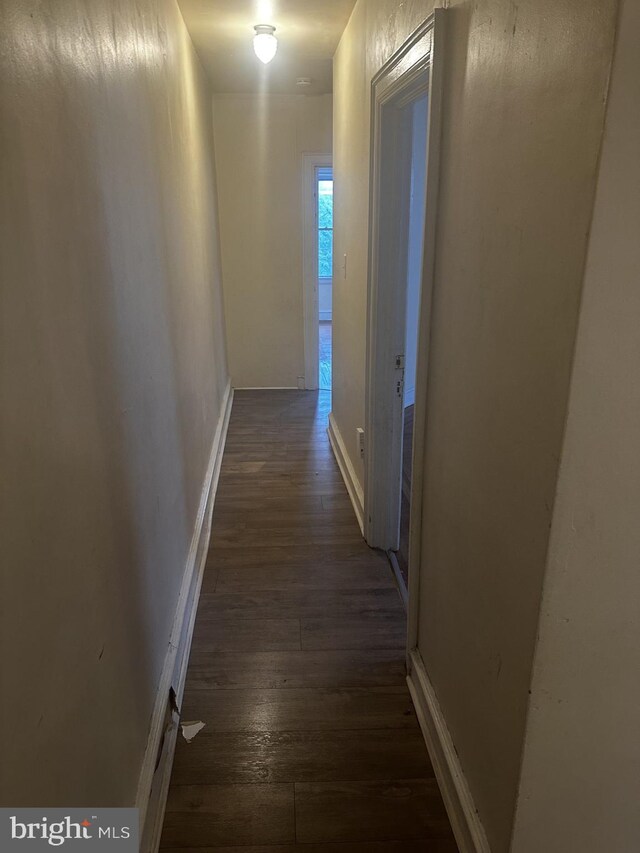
[333,0,616,853]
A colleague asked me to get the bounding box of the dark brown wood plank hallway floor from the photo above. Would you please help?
[161,391,457,853]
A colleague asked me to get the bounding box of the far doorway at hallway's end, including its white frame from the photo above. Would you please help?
[302,154,333,391]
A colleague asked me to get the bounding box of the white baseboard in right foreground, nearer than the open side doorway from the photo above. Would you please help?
[407,649,491,853]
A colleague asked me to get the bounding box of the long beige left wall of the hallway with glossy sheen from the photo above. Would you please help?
[0,0,227,806]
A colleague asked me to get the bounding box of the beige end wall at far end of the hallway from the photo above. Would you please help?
[214,95,332,388]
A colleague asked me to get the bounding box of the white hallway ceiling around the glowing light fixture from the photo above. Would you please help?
[178,0,355,94]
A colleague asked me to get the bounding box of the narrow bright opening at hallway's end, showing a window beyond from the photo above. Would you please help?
[316,167,333,391]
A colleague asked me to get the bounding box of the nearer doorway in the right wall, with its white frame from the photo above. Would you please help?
[365,12,440,604]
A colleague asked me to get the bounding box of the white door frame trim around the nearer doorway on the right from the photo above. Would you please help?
[364,9,447,649]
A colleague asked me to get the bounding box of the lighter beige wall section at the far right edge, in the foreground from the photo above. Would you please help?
[513,0,640,853]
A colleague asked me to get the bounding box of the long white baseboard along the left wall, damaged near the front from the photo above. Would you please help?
[136,383,233,853]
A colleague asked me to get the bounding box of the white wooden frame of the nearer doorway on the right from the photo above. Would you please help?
[364,9,446,650]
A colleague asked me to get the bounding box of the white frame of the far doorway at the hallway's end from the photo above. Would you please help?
[302,153,333,391]
